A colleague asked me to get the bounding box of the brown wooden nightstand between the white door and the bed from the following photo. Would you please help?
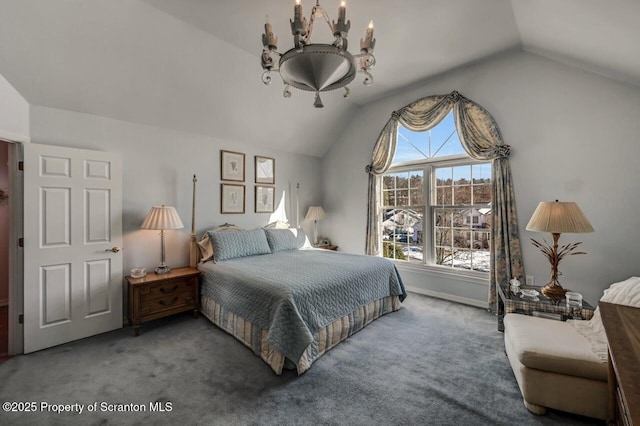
[126,267,200,336]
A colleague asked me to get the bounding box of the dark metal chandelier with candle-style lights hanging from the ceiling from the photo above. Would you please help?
[261,0,376,108]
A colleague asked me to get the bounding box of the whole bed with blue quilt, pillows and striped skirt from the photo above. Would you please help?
[192,224,406,375]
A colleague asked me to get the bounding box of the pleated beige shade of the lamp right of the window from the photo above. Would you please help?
[527,200,593,234]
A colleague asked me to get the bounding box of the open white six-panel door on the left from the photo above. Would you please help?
[24,144,122,353]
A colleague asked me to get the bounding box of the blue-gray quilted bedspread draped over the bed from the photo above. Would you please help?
[199,250,406,363]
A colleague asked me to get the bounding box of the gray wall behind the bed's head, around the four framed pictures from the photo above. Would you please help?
[31,106,321,274]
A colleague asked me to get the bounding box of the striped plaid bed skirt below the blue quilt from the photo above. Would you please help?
[200,295,400,375]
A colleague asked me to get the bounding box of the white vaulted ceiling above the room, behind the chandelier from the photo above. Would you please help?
[0,0,640,156]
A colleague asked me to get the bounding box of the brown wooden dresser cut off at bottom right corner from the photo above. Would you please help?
[598,302,640,426]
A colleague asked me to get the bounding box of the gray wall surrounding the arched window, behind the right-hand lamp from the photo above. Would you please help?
[322,52,640,304]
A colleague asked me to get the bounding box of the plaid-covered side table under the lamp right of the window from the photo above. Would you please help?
[496,283,595,331]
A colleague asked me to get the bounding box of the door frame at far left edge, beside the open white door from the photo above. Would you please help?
[0,130,31,355]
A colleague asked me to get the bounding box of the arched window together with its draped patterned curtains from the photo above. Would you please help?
[365,91,524,309]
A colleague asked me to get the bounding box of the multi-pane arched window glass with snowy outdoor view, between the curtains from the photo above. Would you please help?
[380,113,491,272]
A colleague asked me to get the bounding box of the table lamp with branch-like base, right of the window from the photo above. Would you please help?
[527,200,593,299]
